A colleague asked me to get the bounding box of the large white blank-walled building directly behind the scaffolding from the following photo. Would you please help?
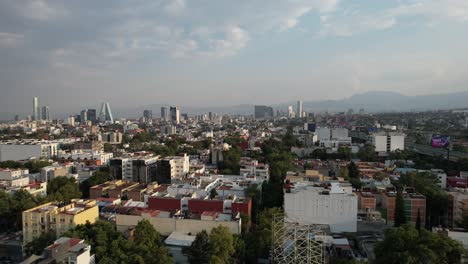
[284,182,358,233]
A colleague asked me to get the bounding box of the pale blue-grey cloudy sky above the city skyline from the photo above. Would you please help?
[0,0,468,113]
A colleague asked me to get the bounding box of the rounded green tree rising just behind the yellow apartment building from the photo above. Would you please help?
[47,176,81,203]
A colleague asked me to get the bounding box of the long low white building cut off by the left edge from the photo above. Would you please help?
[0,140,59,161]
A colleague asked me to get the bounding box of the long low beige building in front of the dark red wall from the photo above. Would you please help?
[115,210,241,236]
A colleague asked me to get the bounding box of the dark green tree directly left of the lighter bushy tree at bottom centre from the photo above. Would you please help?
[184,230,211,264]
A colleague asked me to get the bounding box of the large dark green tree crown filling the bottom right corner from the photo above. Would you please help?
[375,225,465,264]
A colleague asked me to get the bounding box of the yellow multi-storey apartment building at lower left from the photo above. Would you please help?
[23,199,99,244]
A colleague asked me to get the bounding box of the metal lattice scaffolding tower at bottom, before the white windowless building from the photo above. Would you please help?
[271,214,325,264]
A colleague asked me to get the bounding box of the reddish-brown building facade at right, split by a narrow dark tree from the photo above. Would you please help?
[382,192,426,225]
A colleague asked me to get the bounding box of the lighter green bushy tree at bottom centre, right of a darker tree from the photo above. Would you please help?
[210,225,235,263]
